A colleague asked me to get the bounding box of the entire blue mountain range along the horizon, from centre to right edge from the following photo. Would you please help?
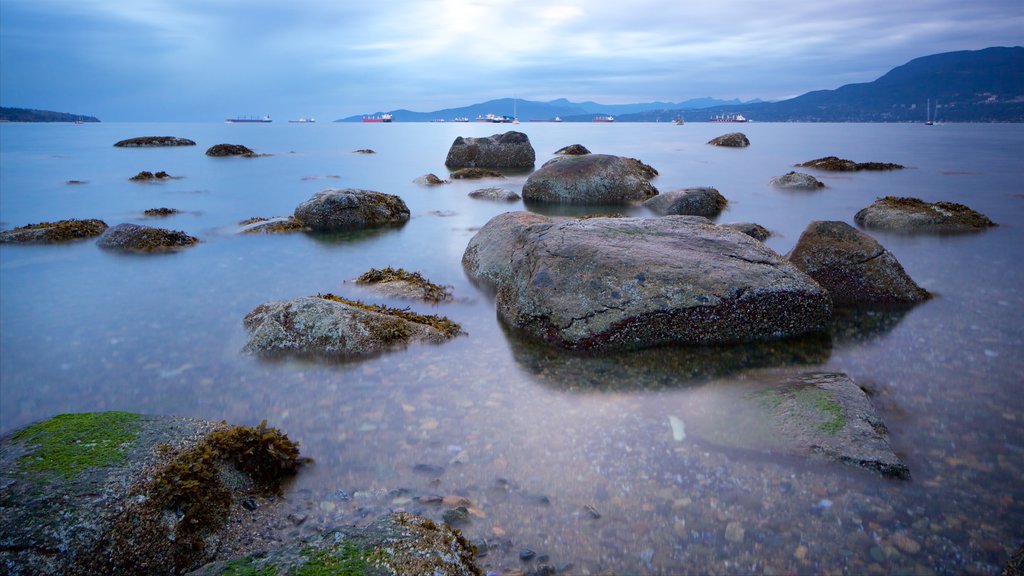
[337,46,1024,122]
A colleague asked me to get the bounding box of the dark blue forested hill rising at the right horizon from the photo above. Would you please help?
[615,46,1024,122]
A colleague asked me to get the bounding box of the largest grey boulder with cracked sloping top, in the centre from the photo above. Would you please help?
[463,214,831,349]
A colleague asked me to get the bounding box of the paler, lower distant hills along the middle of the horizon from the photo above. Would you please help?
[335,97,761,122]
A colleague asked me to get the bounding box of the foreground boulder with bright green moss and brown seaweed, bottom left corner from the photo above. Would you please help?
[0,412,300,576]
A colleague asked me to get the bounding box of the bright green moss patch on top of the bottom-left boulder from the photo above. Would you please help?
[13,412,139,479]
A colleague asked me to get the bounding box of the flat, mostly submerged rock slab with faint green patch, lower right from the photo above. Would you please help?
[682,373,910,479]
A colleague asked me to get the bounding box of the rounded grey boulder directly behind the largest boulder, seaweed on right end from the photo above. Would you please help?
[522,154,657,204]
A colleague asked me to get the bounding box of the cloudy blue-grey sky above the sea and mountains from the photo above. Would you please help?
[0,0,1024,122]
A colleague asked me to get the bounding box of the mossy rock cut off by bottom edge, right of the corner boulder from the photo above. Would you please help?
[193,512,481,576]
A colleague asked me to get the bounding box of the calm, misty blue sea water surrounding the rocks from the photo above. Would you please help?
[0,123,1024,574]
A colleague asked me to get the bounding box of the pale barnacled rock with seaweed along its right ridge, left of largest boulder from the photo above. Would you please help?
[244,294,462,358]
